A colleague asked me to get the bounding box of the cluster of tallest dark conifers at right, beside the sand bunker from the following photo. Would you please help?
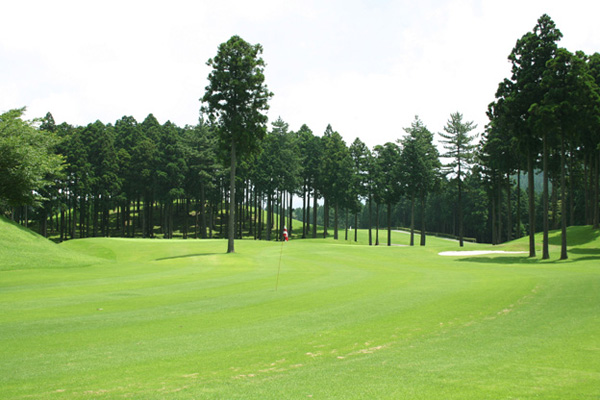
[481,15,600,259]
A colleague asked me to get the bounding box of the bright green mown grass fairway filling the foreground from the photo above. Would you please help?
[0,220,600,399]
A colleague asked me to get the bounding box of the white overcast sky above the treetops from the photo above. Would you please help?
[0,0,600,147]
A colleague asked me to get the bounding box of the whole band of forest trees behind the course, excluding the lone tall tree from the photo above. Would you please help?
[0,15,600,258]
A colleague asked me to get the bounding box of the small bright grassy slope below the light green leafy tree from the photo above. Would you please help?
[0,216,96,271]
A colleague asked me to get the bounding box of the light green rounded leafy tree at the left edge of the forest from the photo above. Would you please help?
[0,108,63,207]
